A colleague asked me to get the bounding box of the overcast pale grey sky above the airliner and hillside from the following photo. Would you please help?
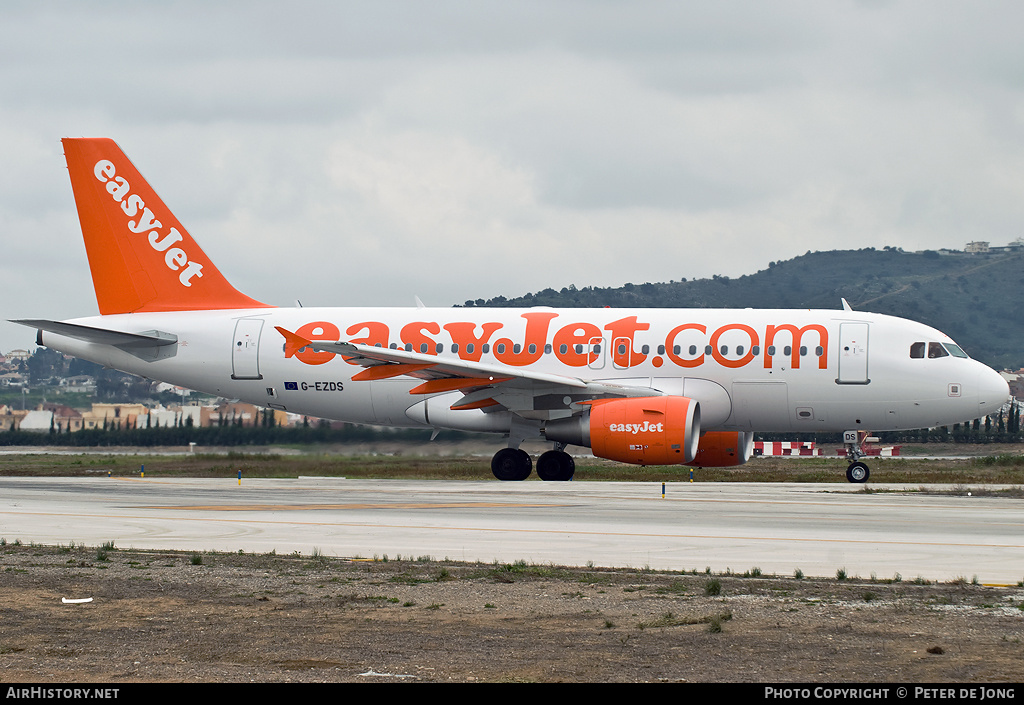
[0,0,1024,351]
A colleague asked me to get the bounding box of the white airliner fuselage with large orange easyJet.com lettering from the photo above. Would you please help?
[41,307,1007,432]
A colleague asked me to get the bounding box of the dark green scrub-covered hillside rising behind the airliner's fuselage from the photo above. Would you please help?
[466,248,1024,369]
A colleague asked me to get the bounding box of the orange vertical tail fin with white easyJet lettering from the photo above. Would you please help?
[61,139,268,315]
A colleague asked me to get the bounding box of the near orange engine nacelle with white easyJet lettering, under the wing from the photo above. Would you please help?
[544,397,700,465]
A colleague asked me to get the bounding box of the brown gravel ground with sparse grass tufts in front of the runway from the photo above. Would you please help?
[0,544,1024,683]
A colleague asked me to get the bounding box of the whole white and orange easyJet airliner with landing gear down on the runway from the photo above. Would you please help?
[16,138,1009,482]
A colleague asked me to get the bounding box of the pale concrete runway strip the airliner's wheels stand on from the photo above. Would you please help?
[0,478,1024,584]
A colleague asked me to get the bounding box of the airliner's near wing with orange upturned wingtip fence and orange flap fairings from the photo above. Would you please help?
[276,326,664,417]
